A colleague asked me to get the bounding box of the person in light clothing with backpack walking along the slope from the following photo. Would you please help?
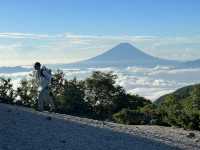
[34,62,55,111]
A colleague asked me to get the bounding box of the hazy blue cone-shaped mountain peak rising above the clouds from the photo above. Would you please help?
[60,43,181,67]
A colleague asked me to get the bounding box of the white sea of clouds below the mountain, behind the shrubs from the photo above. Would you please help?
[0,66,200,101]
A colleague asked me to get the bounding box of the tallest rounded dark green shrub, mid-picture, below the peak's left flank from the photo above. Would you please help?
[85,71,121,120]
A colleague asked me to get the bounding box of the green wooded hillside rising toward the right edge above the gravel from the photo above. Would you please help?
[155,84,200,130]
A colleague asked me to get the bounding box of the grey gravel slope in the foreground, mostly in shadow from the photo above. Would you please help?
[0,104,200,150]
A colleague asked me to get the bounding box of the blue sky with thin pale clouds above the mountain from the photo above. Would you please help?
[0,0,200,65]
